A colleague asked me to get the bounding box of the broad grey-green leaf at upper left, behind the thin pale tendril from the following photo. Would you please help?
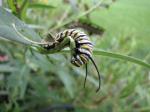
[0,7,40,45]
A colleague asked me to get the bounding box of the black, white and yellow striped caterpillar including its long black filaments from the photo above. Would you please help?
[44,29,101,92]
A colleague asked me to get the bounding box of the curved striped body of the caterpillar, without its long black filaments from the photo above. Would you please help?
[56,29,93,67]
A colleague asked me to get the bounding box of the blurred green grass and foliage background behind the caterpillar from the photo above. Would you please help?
[0,0,150,112]
